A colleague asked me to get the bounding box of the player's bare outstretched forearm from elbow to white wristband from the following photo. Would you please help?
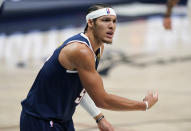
[99,94,146,111]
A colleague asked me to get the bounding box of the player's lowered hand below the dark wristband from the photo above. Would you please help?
[97,118,114,131]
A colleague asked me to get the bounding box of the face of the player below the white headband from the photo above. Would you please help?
[93,15,116,44]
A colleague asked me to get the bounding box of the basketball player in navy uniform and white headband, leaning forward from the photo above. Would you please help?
[20,4,158,131]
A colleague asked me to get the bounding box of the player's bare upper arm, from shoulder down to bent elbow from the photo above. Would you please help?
[60,44,107,106]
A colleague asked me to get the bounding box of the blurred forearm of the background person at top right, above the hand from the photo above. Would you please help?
[165,0,179,17]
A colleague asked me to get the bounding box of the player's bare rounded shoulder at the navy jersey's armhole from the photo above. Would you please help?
[59,42,94,69]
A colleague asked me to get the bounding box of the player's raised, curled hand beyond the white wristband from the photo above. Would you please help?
[143,91,158,109]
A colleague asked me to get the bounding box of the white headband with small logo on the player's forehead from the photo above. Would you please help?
[86,8,116,22]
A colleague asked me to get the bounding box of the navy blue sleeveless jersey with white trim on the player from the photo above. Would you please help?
[21,33,100,122]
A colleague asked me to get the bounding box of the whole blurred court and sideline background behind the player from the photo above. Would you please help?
[0,0,191,131]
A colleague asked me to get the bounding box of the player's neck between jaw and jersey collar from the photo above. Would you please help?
[85,32,103,52]
